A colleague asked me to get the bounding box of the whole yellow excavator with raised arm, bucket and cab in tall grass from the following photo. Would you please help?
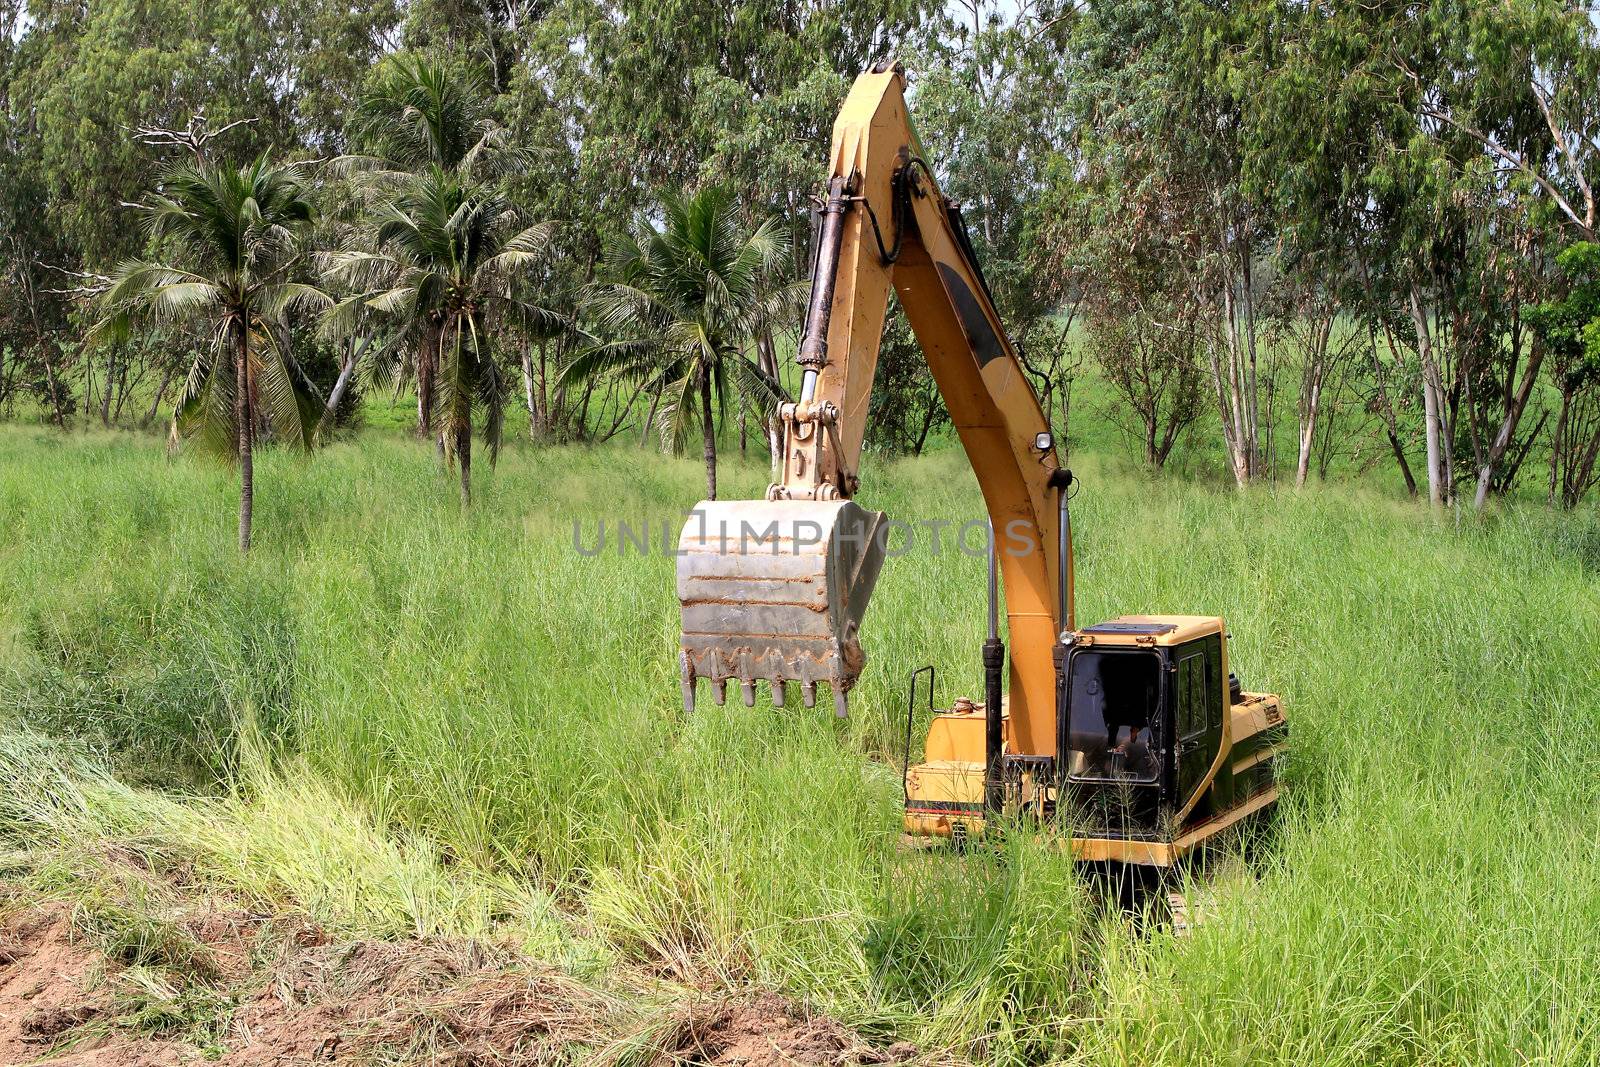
[677,64,1288,867]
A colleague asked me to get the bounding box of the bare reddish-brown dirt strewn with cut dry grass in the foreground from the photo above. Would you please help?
[0,904,912,1067]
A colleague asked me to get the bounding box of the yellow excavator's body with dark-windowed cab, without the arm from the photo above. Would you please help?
[906,616,1288,867]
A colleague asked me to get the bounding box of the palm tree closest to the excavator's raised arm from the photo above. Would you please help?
[565,187,800,499]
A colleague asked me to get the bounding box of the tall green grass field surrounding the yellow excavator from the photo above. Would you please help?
[0,429,1600,1064]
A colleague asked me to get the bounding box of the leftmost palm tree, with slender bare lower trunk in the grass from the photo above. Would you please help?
[96,155,328,552]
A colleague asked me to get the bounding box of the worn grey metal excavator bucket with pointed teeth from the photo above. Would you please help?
[678,501,888,717]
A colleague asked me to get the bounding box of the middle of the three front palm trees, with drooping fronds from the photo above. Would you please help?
[323,166,554,504]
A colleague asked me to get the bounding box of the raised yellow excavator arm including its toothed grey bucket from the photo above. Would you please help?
[678,66,1074,757]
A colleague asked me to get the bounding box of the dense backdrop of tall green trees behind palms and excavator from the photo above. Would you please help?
[0,0,1600,506]
